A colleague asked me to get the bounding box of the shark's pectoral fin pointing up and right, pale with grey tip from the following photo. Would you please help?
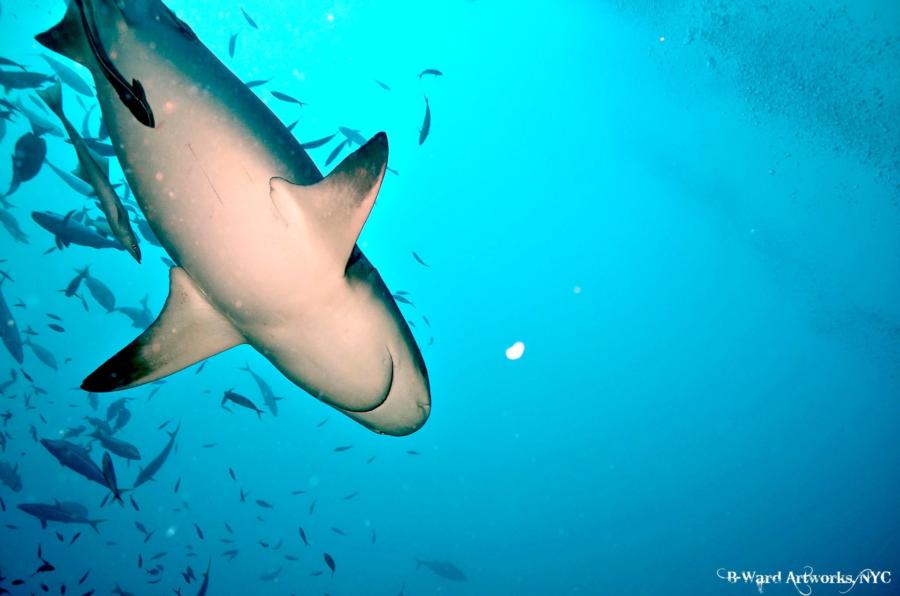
[269,132,388,273]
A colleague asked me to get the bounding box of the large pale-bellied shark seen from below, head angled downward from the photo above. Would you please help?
[36,0,431,435]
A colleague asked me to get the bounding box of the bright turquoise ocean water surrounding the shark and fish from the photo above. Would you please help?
[0,0,900,595]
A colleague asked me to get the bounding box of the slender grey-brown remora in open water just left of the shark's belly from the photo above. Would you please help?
[38,83,141,263]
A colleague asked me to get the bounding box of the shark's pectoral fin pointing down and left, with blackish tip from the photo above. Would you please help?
[81,267,245,392]
